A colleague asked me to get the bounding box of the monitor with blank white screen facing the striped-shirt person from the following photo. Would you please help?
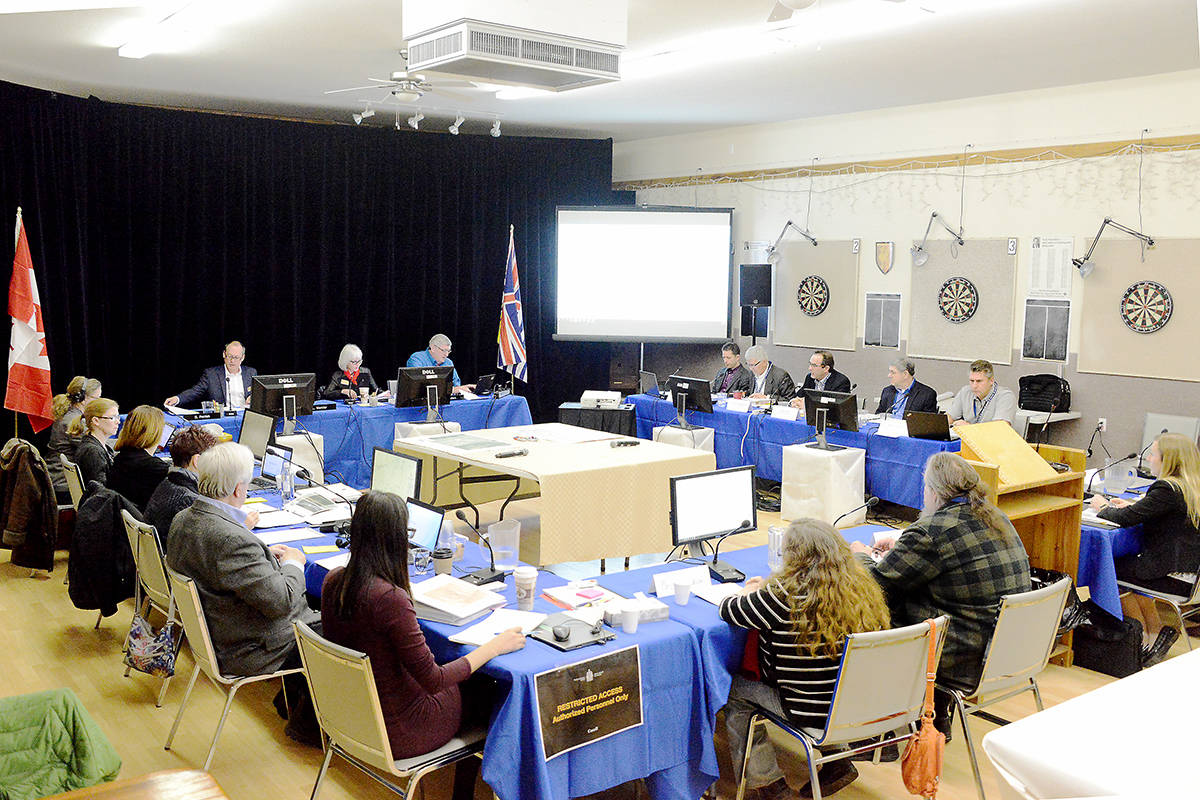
[671,465,758,547]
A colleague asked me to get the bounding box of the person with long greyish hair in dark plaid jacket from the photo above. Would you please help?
[854,452,1031,738]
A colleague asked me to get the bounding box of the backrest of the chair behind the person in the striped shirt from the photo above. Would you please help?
[822,616,946,745]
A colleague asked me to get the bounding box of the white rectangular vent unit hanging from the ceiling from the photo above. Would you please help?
[408,19,624,91]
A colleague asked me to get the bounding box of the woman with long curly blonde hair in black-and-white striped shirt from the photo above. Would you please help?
[720,519,889,800]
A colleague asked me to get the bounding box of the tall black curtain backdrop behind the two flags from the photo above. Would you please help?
[0,82,632,434]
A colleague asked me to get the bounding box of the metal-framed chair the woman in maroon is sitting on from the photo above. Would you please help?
[293,622,485,800]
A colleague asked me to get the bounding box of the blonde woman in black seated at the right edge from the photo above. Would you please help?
[1092,433,1200,667]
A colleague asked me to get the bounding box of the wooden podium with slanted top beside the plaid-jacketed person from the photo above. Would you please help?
[958,421,1087,667]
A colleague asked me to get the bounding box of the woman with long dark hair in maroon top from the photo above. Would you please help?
[320,492,524,798]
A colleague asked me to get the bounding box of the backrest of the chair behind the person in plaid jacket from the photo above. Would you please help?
[972,578,1070,697]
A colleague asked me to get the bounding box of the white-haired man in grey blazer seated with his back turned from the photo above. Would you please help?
[167,441,320,744]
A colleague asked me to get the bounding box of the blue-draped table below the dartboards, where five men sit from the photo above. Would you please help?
[625,395,961,509]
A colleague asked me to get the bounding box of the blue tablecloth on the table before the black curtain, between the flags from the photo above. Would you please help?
[172,395,533,488]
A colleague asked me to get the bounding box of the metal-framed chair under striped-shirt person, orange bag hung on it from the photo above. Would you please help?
[737,616,946,800]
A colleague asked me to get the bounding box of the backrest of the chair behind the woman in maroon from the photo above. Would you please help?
[293,622,401,775]
